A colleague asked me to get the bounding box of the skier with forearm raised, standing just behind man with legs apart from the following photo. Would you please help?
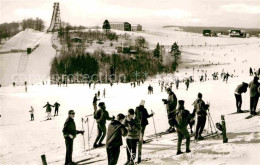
[163,88,177,133]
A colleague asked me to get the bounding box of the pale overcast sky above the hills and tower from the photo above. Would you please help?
[0,0,260,28]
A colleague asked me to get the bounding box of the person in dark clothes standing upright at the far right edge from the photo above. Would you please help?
[249,76,260,115]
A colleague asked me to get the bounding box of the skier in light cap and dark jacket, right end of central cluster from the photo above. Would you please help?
[135,100,153,163]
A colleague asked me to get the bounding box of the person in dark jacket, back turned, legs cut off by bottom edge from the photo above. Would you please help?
[106,113,127,165]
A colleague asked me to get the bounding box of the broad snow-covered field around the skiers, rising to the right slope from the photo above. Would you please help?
[0,27,260,165]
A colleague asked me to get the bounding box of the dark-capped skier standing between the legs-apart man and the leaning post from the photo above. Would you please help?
[193,93,207,140]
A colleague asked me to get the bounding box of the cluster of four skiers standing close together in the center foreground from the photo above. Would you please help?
[93,100,153,165]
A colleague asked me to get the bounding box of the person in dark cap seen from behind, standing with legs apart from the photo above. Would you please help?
[175,100,191,155]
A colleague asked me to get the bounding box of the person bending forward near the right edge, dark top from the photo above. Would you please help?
[235,82,248,113]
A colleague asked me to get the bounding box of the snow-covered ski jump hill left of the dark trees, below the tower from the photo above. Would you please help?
[0,29,56,86]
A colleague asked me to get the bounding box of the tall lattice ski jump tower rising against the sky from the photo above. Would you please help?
[47,2,61,32]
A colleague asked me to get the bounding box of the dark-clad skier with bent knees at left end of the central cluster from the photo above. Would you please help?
[93,102,115,148]
